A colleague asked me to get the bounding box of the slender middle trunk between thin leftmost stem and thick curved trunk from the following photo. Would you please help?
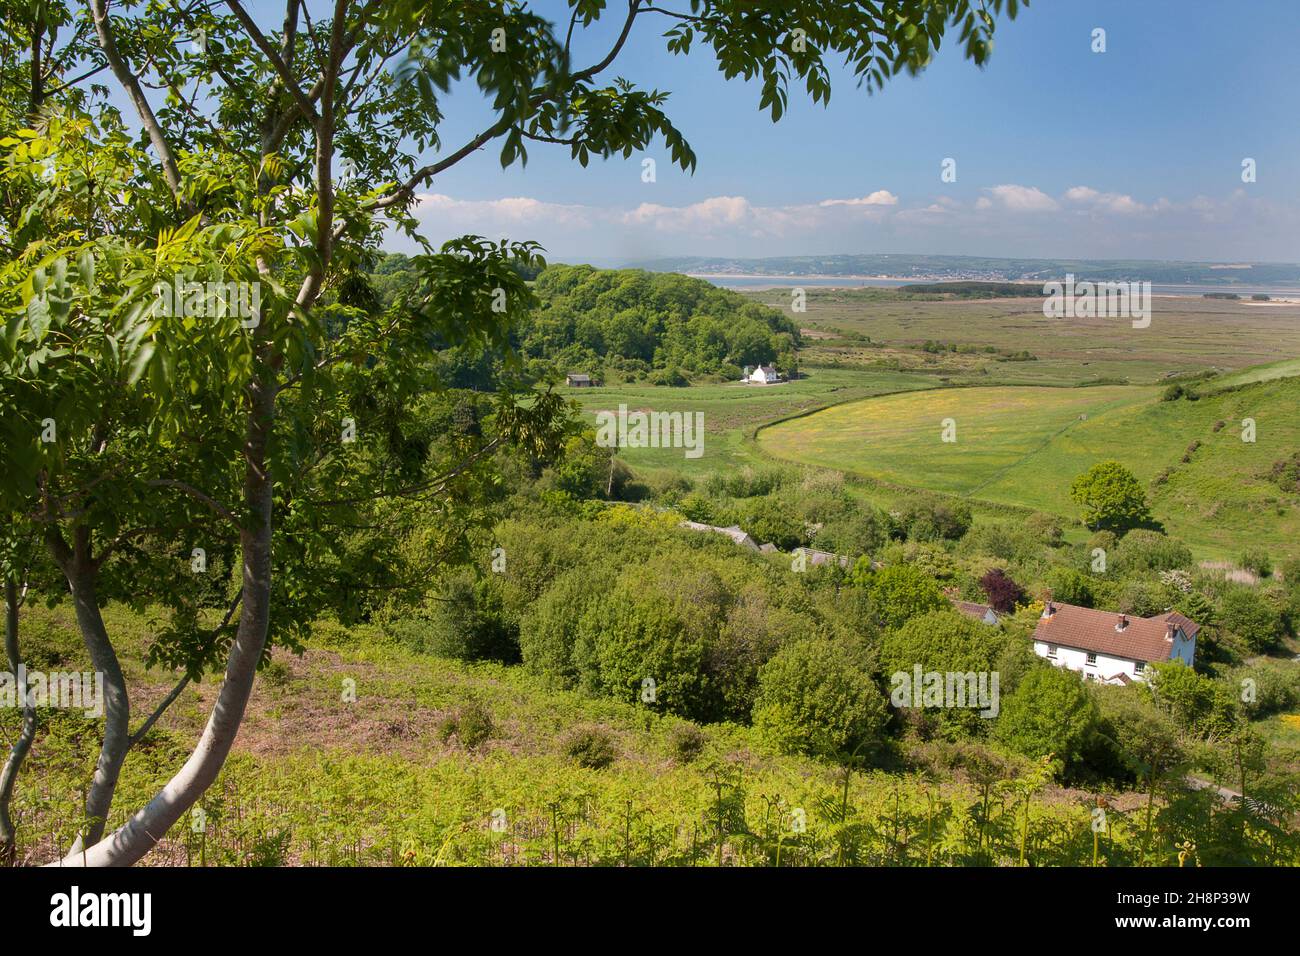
[64,561,131,853]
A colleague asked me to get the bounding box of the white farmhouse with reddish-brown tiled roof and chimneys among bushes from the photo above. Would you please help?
[1034,600,1201,684]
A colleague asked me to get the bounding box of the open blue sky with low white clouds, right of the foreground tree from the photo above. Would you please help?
[389,0,1300,265]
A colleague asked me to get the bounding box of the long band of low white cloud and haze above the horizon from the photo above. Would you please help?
[398,183,1300,260]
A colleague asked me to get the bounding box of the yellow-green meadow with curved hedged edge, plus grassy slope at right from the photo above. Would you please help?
[758,378,1300,558]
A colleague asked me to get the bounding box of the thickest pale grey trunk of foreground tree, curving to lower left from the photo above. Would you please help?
[57,380,276,866]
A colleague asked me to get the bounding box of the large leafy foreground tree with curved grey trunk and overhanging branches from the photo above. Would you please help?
[0,0,1018,865]
